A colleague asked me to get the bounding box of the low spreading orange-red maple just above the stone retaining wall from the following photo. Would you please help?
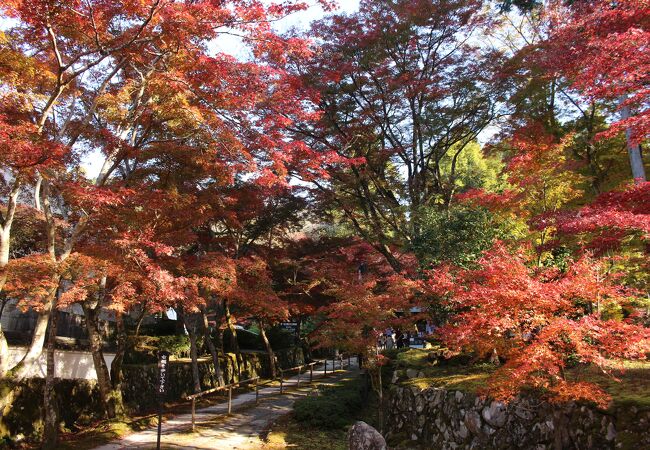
[429,244,650,405]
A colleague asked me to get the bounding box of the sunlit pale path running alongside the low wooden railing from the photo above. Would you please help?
[94,360,358,450]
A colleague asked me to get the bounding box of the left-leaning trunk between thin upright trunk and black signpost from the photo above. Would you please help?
[81,302,124,419]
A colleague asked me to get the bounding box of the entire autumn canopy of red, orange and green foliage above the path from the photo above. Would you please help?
[0,0,650,442]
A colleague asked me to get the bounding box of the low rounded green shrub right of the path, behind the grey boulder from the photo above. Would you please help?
[294,380,363,429]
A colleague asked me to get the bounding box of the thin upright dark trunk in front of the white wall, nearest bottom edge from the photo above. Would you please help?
[41,311,59,450]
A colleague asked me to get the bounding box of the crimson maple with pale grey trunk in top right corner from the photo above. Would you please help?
[547,0,650,181]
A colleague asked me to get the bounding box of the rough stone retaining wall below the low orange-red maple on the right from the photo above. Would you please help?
[385,385,650,450]
